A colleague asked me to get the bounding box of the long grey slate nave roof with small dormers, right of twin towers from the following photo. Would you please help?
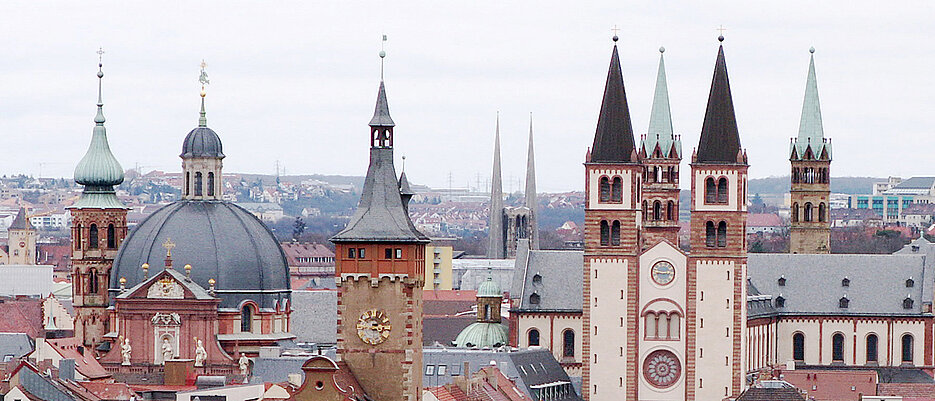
[747,253,933,316]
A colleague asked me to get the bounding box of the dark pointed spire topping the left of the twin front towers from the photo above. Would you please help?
[591,40,636,163]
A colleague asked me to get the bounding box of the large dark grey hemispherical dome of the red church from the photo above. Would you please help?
[110,200,290,308]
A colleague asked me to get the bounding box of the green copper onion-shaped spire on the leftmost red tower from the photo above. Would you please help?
[72,49,124,208]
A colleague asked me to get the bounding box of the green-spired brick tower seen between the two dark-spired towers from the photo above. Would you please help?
[640,47,682,246]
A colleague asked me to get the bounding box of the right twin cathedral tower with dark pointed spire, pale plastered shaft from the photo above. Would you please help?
[685,36,748,400]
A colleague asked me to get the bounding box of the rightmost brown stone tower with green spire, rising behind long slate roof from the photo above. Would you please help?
[789,48,831,253]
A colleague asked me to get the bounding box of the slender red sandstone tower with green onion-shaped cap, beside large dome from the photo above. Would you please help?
[69,57,127,347]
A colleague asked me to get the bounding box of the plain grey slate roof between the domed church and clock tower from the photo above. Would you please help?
[289,290,338,344]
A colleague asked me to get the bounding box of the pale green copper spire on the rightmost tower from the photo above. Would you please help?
[791,47,831,160]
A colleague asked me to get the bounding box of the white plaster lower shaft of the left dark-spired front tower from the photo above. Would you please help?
[583,256,636,401]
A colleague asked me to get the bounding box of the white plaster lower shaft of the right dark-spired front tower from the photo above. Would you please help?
[694,261,746,400]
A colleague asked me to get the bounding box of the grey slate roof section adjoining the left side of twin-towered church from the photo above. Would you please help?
[510,241,584,312]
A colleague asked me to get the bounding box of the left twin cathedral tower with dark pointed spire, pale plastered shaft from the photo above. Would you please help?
[582,36,643,400]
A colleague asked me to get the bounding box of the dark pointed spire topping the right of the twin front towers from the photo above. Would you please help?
[695,36,742,164]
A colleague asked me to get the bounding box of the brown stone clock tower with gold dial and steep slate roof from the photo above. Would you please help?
[331,73,429,401]
